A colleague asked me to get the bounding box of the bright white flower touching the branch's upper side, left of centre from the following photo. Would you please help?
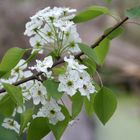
[30,56,53,78]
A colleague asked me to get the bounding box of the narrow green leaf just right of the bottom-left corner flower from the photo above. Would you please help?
[20,109,33,134]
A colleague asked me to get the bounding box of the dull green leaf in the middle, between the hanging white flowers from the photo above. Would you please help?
[43,79,63,100]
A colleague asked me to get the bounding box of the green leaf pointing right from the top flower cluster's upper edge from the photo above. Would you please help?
[73,6,109,23]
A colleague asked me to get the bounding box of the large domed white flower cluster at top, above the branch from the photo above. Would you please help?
[24,7,81,56]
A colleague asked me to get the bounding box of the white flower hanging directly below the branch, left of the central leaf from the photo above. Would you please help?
[29,81,47,105]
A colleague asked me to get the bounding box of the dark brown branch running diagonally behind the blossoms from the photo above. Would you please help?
[0,17,129,94]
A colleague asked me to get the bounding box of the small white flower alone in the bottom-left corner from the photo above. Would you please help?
[2,118,20,133]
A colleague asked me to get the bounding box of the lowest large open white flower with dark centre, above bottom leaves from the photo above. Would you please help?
[34,99,65,125]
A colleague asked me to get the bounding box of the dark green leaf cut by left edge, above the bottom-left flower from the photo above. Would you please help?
[0,94,16,117]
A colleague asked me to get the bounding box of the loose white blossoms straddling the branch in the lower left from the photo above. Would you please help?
[0,56,65,133]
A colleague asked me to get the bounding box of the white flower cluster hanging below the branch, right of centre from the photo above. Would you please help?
[58,56,96,100]
